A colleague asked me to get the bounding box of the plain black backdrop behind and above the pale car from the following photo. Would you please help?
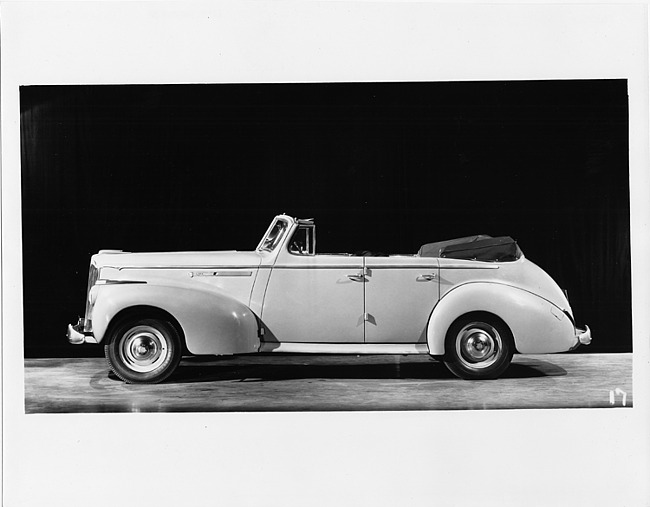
[20,80,632,357]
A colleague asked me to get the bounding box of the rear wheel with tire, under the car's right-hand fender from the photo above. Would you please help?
[444,314,514,380]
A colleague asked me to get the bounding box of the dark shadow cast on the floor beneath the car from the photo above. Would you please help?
[110,358,566,384]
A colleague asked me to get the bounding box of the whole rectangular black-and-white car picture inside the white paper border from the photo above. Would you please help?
[21,80,633,413]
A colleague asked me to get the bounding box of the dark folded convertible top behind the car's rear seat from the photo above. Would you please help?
[418,234,521,262]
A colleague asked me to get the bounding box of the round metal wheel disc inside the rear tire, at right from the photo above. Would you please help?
[456,322,503,368]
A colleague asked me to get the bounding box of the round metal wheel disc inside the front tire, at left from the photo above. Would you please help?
[119,326,169,373]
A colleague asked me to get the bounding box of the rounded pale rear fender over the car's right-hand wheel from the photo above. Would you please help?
[427,282,575,355]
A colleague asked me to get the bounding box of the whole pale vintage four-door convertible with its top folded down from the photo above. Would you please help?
[68,214,591,383]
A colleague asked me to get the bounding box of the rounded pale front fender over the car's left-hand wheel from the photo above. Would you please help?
[92,283,260,355]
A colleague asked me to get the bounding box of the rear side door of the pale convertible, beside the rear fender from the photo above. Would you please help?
[365,256,440,343]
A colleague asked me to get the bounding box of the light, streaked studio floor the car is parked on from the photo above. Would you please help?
[25,353,632,414]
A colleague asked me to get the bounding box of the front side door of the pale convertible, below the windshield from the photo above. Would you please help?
[261,254,364,343]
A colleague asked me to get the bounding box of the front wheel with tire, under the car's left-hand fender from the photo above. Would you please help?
[104,318,182,384]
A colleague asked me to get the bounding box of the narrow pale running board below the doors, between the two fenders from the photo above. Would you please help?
[259,342,429,354]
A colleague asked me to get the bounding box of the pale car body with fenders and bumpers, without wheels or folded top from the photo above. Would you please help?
[68,215,591,372]
